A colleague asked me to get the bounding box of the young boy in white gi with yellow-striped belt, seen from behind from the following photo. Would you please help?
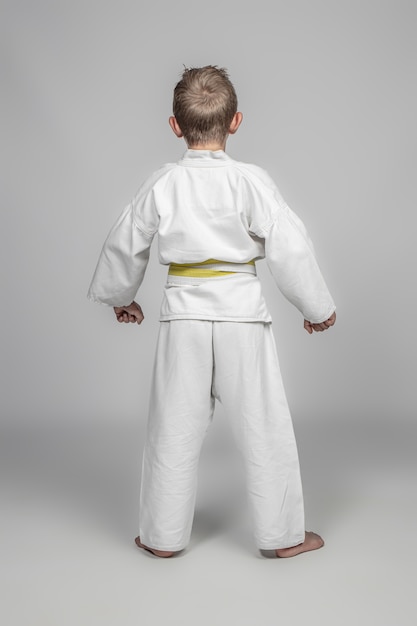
[88,66,336,557]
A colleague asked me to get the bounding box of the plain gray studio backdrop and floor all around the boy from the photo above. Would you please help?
[0,0,417,626]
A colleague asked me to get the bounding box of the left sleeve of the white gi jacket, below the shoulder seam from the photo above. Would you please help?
[87,193,158,306]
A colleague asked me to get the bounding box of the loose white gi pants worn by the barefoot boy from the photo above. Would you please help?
[140,320,305,551]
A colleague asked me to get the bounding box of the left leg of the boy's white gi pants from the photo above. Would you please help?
[140,320,214,551]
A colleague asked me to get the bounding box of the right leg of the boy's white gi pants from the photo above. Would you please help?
[213,322,305,550]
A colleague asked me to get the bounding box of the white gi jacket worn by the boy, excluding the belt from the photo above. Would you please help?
[88,150,335,323]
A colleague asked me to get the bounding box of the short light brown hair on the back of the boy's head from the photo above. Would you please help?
[173,65,237,146]
